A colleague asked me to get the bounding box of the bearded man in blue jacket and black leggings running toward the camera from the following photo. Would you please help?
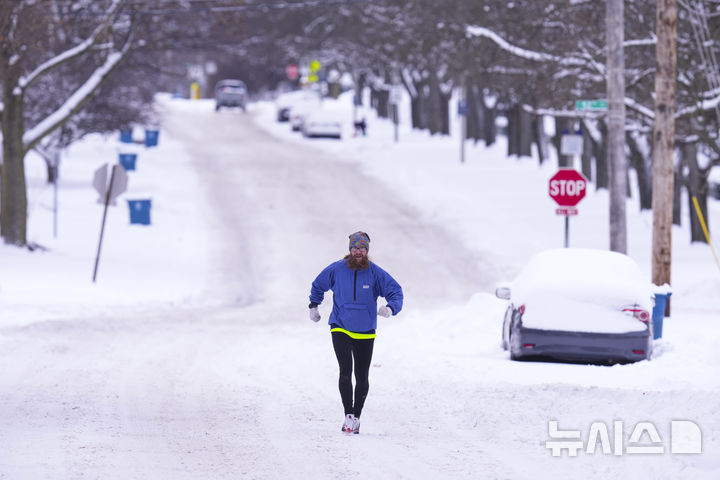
[309,232,403,434]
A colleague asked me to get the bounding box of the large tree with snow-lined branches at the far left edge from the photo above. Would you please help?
[0,0,133,246]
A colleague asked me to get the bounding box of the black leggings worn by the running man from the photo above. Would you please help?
[331,332,375,418]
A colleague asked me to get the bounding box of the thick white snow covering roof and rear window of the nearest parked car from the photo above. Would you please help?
[512,248,653,310]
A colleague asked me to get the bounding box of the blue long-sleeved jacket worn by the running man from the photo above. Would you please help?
[310,260,403,332]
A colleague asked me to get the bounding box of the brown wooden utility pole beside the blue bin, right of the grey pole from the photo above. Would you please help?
[652,0,678,300]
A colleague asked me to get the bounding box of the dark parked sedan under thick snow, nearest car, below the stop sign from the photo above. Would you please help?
[495,248,654,363]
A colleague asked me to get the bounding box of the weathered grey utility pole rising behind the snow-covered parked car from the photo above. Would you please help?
[605,0,627,253]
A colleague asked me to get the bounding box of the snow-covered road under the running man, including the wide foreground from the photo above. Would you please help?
[0,99,720,480]
